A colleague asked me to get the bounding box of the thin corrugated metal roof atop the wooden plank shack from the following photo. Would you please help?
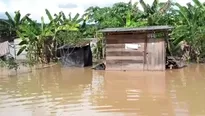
[99,26,173,33]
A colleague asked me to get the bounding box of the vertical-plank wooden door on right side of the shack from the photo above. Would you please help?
[146,38,166,71]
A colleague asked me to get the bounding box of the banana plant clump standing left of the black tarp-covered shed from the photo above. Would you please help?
[17,17,54,62]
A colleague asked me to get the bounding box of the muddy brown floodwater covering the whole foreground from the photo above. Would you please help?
[0,65,205,116]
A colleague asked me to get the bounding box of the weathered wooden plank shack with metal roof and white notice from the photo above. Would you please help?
[100,26,172,71]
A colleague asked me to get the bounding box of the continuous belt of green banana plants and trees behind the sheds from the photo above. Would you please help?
[0,0,205,67]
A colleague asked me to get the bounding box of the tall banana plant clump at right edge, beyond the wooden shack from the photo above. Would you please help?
[172,0,205,61]
